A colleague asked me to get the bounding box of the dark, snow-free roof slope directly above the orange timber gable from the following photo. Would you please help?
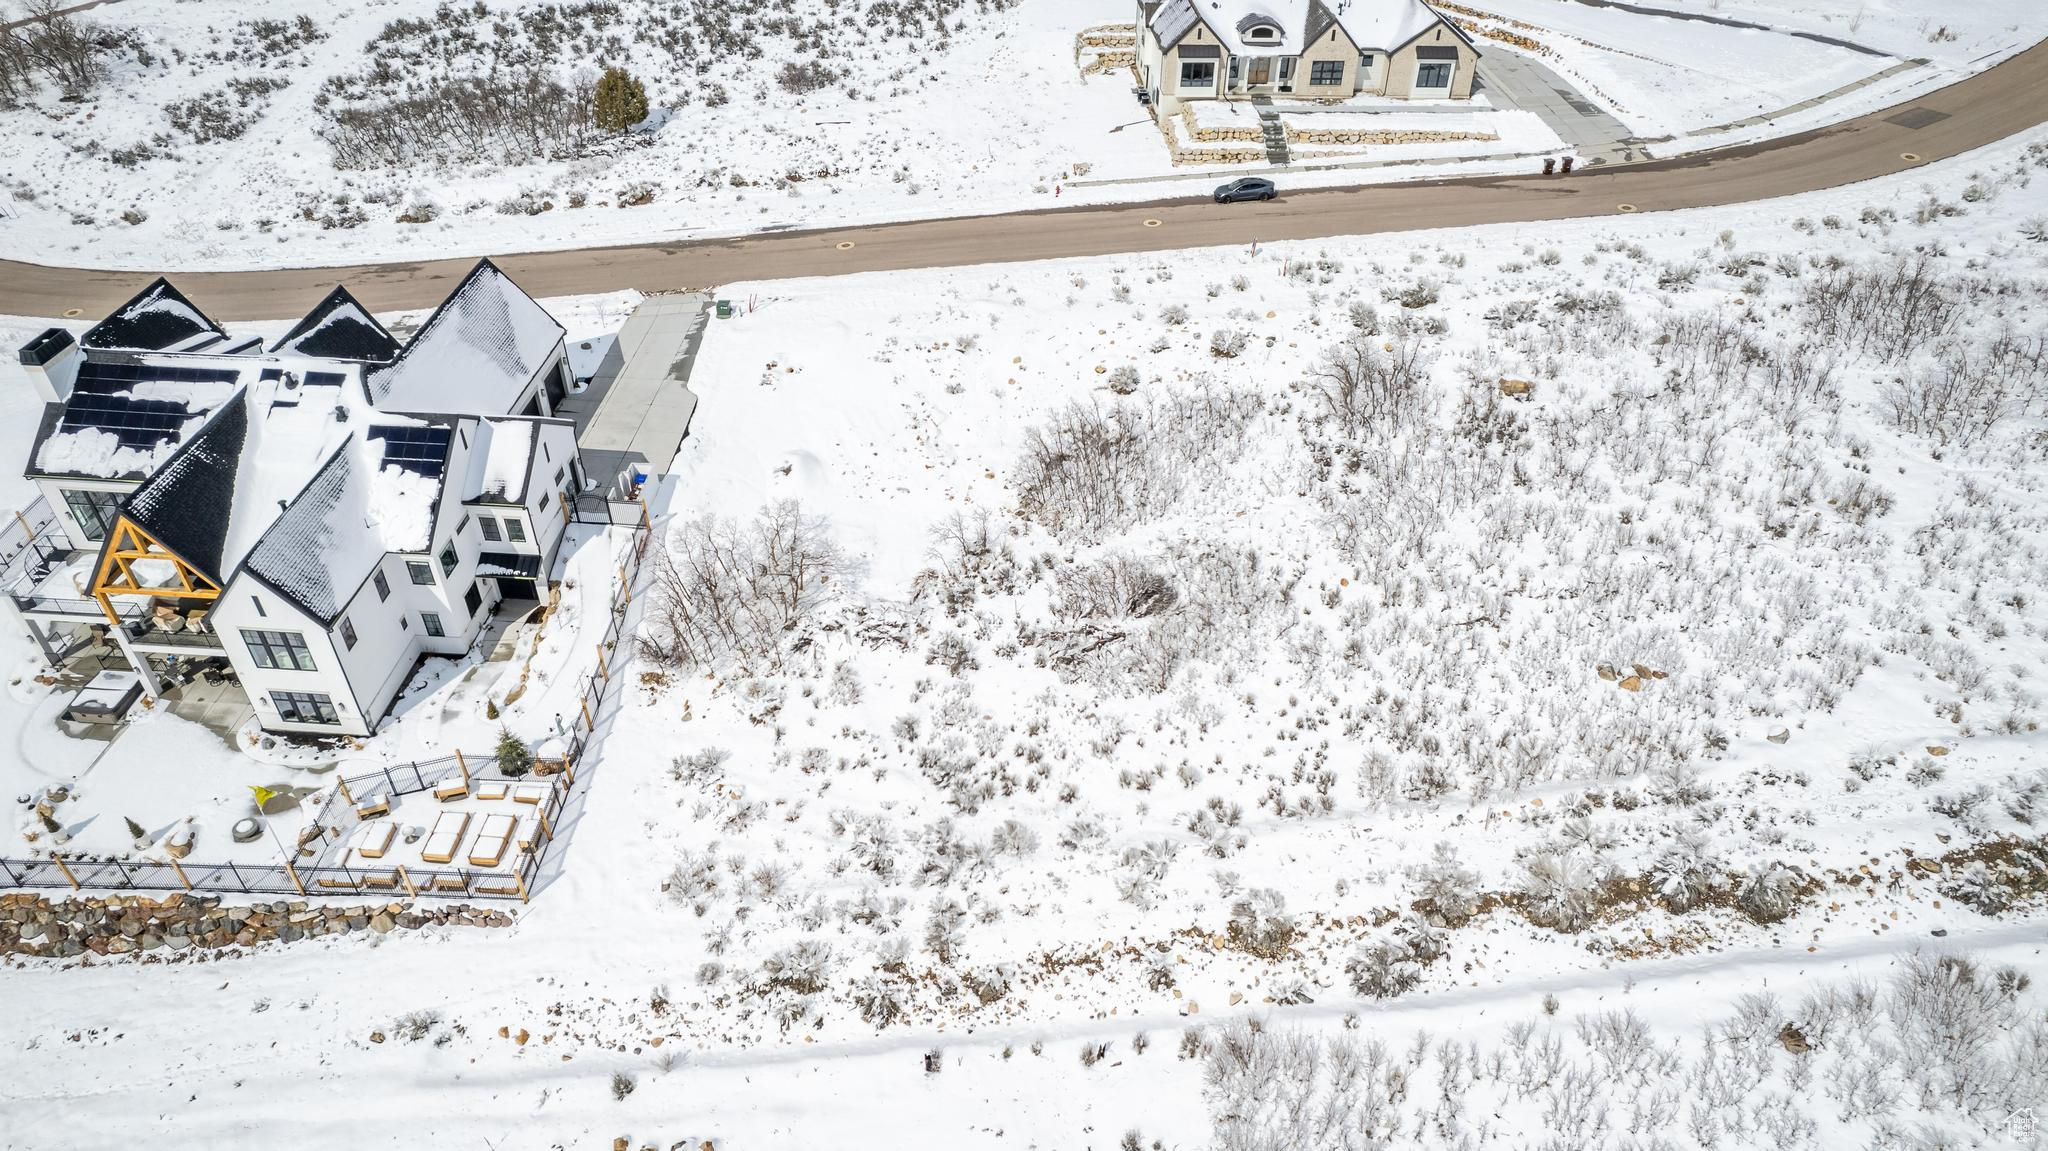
[123,391,250,584]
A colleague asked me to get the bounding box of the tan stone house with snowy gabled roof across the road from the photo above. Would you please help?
[1137,0,1479,113]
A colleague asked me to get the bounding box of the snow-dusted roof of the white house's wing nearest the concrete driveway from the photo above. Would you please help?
[365,260,563,416]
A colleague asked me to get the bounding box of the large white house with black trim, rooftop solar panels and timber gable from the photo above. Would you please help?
[8,260,584,735]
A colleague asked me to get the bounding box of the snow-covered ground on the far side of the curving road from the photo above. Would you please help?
[0,0,2048,268]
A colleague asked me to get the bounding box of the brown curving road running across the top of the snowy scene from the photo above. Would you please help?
[0,43,2048,319]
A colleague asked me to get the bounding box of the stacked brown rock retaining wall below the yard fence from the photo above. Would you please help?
[0,893,512,958]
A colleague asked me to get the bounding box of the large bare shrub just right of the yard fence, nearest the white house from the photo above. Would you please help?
[641,500,844,668]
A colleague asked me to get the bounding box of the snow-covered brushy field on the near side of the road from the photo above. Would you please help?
[0,109,2048,1149]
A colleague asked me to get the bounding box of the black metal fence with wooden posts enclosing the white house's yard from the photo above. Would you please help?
[0,500,653,899]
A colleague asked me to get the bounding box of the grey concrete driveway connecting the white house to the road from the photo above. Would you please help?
[559,293,711,489]
